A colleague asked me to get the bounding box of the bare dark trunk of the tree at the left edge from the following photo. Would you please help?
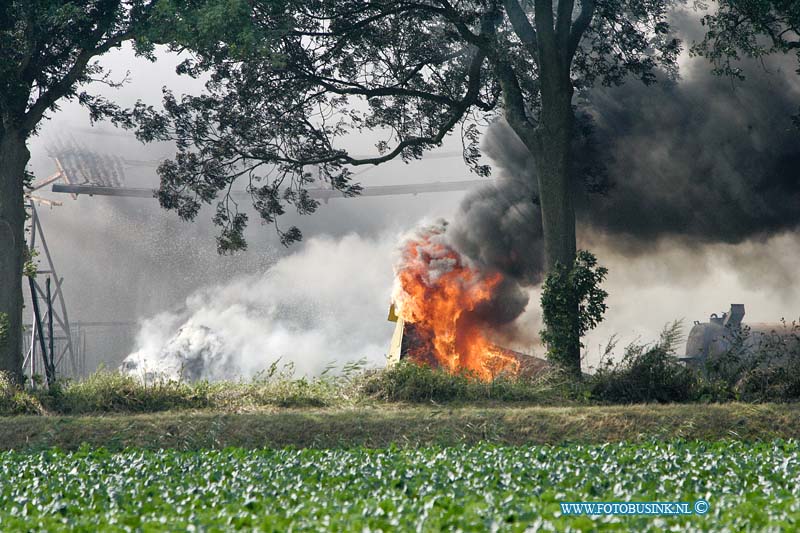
[0,131,30,382]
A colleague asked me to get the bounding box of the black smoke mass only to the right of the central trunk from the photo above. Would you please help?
[579,68,800,248]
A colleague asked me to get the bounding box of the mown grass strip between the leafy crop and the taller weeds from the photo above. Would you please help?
[0,403,800,450]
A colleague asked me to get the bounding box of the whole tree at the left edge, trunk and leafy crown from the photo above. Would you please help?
[0,0,155,379]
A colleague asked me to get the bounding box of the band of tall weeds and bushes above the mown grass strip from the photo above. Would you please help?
[0,324,800,415]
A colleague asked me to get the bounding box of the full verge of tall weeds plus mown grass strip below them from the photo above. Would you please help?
[0,322,800,449]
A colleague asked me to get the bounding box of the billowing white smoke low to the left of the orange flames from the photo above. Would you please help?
[122,235,397,380]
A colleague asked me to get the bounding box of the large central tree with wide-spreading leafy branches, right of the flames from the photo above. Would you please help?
[137,0,679,373]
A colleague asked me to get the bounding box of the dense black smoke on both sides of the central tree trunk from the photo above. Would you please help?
[451,46,800,298]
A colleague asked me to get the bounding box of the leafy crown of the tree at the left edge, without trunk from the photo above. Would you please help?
[0,0,156,136]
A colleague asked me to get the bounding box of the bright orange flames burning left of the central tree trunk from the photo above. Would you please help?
[393,225,520,380]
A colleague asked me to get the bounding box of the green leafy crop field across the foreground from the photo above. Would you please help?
[0,440,800,531]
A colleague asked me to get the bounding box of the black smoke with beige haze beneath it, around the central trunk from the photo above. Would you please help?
[438,8,800,360]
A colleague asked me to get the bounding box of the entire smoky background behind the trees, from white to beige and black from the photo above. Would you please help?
[23,7,800,377]
